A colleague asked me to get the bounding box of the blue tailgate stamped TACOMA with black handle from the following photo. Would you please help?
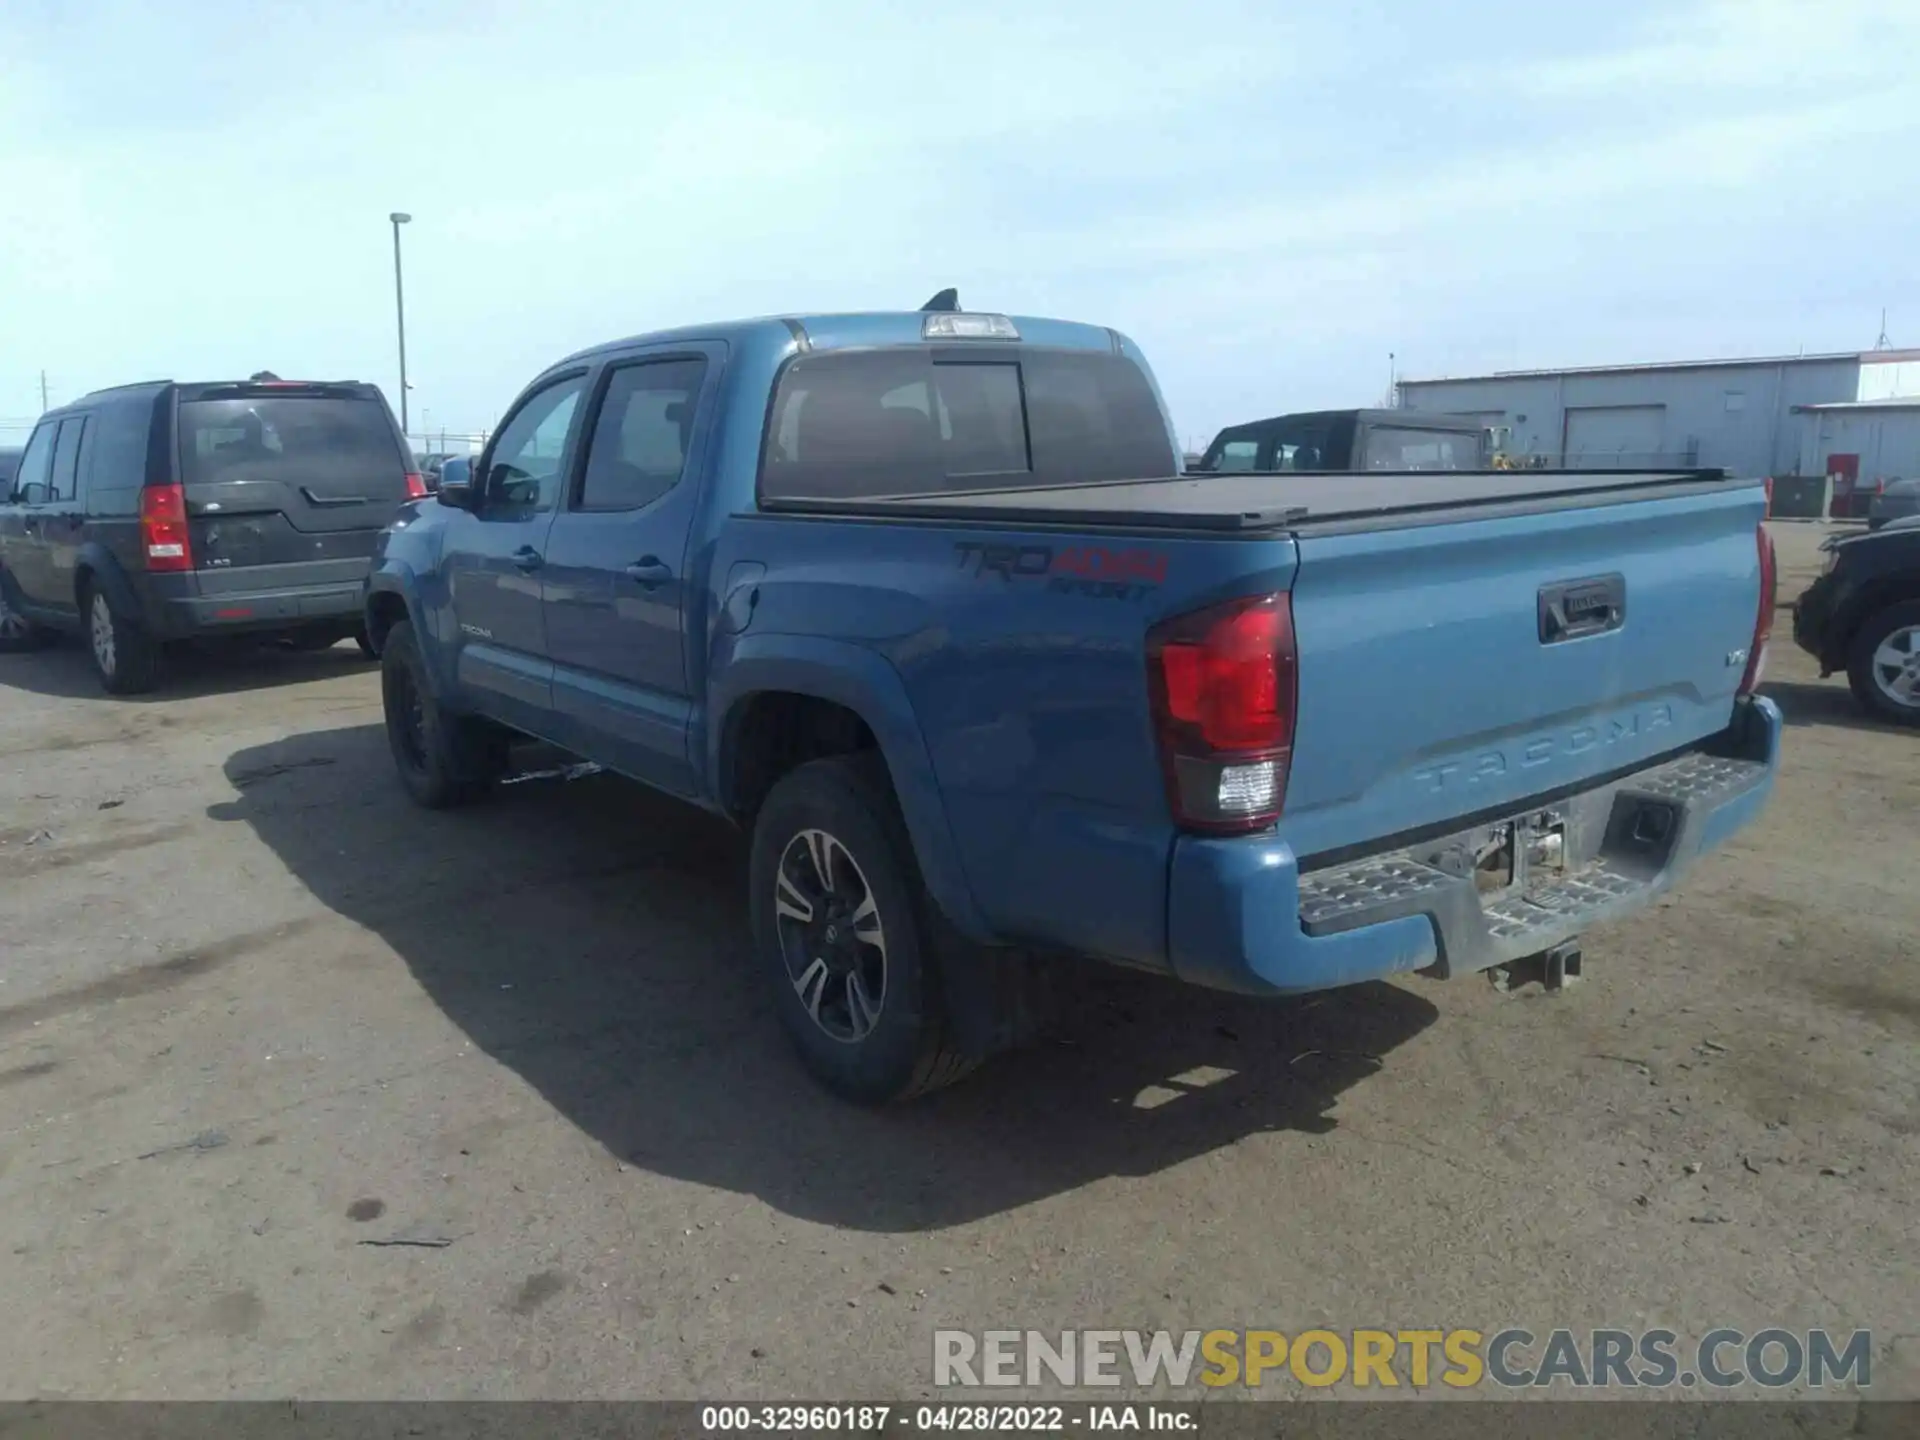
[1281,488,1763,868]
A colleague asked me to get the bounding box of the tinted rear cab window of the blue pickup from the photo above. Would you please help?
[760,346,1179,499]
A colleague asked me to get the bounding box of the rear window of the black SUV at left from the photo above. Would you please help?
[180,396,407,499]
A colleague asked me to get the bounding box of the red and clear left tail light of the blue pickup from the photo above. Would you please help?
[1146,595,1298,833]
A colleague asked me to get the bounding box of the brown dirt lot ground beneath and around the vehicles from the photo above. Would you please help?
[0,526,1920,1398]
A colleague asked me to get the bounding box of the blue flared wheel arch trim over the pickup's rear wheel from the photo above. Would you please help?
[707,636,996,945]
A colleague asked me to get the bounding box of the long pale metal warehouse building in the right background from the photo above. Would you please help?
[1400,349,1920,513]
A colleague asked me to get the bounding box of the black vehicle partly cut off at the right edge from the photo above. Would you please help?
[1793,516,1920,726]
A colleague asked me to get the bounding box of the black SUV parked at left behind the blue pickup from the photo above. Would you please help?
[0,380,426,695]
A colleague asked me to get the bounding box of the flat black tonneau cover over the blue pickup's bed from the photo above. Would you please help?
[760,470,1728,536]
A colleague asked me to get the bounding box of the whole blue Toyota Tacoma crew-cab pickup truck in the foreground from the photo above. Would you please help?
[367,300,1780,1102]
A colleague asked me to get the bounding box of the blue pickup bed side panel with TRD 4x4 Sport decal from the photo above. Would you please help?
[716,516,1294,966]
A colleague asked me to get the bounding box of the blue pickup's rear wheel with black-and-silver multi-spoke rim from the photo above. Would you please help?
[741,756,975,1106]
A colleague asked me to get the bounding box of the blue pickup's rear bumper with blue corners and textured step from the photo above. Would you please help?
[1167,699,1780,995]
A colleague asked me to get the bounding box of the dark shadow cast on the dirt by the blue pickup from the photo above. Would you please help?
[209,726,1436,1231]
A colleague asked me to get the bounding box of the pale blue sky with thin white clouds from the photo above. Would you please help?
[0,0,1920,444]
